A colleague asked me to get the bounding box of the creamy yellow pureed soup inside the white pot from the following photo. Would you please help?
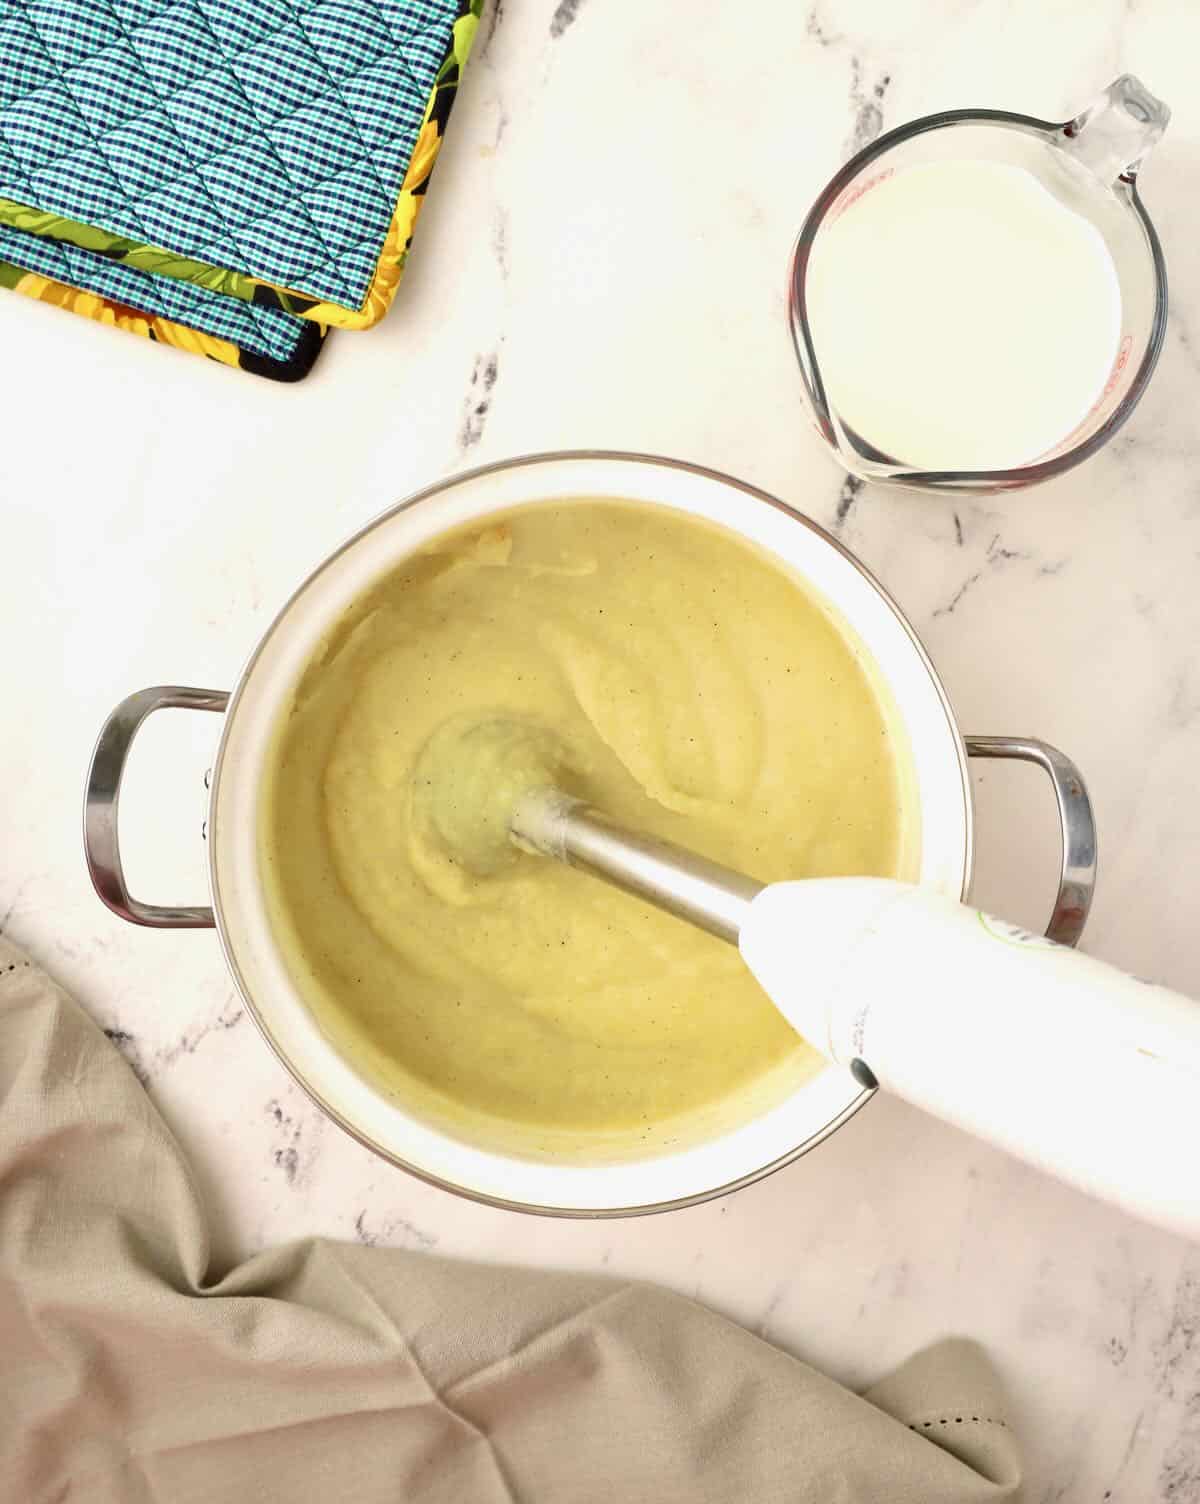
[259,501,917,1161]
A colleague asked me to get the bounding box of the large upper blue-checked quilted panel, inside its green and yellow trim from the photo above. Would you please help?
[0,0,459,308]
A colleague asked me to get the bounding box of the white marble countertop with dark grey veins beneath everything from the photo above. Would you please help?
[0,0,1200,1504]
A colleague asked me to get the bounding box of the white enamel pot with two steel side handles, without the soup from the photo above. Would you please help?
[84,451,1095,1217]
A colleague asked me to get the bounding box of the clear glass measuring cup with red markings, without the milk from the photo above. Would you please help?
[788,74,1170,492]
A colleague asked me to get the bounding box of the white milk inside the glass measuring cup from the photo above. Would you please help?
[805,161,1120,471]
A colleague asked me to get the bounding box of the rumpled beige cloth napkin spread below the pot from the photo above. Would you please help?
[0,940,1020,1504]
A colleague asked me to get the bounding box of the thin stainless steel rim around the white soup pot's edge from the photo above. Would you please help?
[208,450,974,1220]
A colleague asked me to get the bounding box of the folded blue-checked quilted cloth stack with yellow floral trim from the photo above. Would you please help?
[0,0,481,381]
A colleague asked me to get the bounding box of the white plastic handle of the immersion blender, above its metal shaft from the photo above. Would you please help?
[738,877,1200,1238]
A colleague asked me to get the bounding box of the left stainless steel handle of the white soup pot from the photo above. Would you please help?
[83,684,229,929]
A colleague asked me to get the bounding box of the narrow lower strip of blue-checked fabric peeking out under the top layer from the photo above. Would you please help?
[0,216,311,361]
